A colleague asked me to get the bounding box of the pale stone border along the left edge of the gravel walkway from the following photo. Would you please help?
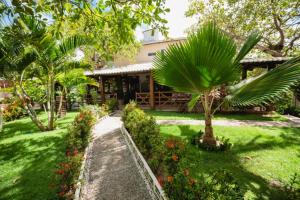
[74,115,110,200]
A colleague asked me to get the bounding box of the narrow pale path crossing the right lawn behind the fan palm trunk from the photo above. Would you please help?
[157,118,300,127]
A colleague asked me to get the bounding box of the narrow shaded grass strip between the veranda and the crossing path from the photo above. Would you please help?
[145,110,288,121]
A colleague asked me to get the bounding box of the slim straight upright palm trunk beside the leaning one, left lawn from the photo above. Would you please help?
[48,67,55,130]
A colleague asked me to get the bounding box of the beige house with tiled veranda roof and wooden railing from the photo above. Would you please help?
[86,30,288,111]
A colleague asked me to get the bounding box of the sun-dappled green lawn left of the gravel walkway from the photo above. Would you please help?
[0,113,76,200]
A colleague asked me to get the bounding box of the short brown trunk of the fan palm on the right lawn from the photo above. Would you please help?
[202,92,217,146]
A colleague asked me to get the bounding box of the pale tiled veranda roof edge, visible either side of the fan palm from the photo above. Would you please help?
[85,57,290,76]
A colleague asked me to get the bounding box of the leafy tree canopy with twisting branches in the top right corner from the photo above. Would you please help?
[186,0,300,57]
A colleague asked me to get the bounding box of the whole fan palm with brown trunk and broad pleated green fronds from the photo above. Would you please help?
[153,23,300,145]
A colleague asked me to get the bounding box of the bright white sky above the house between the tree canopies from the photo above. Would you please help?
[136,0,196,40]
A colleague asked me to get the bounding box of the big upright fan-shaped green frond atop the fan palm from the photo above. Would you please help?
[153,23,240,94]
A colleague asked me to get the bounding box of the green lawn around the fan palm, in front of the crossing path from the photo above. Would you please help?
[161,125,300,199]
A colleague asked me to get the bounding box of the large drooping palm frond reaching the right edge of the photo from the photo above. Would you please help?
[226,56,300,106]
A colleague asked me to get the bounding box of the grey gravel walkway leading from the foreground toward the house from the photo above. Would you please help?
[82,117,152,200]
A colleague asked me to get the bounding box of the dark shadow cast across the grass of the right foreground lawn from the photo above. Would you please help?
[164,125,300,199]
